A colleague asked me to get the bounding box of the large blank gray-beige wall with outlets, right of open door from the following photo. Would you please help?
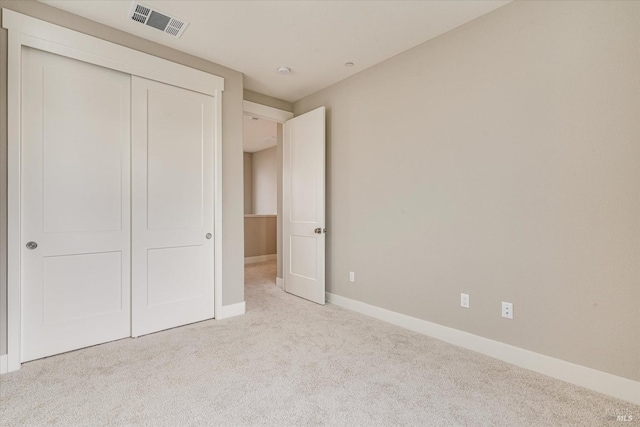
[294,1,640,380]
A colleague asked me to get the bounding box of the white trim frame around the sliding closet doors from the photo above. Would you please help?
[0,9,224,373]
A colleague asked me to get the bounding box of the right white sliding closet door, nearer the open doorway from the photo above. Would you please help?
[132,76,215,336]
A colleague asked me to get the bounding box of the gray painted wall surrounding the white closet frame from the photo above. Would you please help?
[0,0,244,354]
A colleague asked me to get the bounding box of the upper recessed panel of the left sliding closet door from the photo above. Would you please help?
[42,67,128,232]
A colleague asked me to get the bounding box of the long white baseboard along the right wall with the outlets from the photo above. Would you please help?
[326,292,640,405]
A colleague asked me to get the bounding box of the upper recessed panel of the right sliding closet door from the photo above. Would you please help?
[147,90,204,229]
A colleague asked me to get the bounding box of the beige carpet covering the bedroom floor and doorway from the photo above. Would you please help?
[0,263,640,426]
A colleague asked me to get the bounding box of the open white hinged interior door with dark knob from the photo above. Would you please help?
[282,107,326,304]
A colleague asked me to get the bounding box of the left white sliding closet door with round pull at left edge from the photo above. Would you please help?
[21,48,131,361]
